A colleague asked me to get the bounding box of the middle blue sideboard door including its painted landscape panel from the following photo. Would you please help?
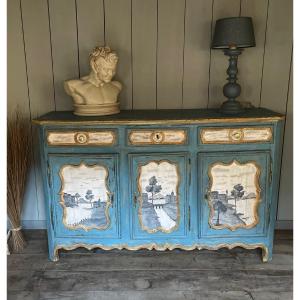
[130,153,189,240]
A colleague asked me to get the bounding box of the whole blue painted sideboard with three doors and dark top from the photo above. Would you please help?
[34,108,284,261]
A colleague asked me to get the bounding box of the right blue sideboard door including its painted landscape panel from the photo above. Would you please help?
[198,152,271,237]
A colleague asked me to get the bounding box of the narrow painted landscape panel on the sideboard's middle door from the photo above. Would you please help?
[138,161,179,233]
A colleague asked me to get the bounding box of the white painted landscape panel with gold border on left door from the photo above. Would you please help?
[60,163,110,230]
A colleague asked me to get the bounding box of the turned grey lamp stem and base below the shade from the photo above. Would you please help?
[221,48,244,114]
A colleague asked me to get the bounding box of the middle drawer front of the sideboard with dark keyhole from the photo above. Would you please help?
[128,128,187,146]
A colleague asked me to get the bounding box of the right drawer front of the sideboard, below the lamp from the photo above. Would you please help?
[200,127,273,144]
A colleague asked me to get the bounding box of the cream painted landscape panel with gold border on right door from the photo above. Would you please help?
[209,161,260,230]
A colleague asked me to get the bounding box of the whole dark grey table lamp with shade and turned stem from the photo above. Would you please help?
[211,17,255,114]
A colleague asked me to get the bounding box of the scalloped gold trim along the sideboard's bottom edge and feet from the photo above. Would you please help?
[53,243,269,262]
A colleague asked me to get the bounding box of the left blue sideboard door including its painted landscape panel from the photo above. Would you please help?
[48,154,119,238]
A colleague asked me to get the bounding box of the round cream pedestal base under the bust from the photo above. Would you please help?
[74,102,120,116]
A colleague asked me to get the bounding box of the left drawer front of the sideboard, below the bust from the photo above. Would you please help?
[47,130,117,146]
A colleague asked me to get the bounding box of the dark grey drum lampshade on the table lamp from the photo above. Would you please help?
[211,17,255,49]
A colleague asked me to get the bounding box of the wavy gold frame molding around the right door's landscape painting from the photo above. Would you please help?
[207,159,261,231]
